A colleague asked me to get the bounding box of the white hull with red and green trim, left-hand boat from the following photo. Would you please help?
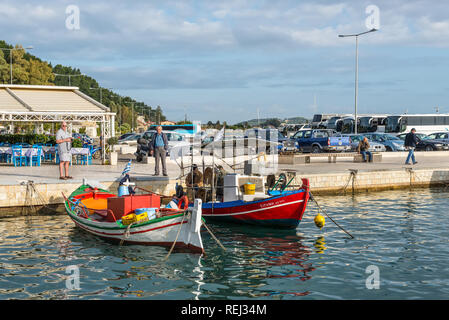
[65,186,204,253]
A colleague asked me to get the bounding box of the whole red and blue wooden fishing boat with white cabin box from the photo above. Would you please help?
[192,175,309,228]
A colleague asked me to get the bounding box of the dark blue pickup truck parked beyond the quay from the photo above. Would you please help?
[286,129,351,153]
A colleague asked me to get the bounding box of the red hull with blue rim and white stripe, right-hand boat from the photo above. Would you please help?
[202,189,309,228]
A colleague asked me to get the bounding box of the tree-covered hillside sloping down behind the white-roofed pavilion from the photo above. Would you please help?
[0,40,166,133]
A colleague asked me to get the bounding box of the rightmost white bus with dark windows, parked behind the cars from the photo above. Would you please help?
[385,113,449,134]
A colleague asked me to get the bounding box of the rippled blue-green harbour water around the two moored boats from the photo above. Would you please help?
[0,189,449,299]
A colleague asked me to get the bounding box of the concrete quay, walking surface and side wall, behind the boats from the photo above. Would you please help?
[0,151,449,217]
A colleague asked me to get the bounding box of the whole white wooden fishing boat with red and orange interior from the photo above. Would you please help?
[63,184,204,253]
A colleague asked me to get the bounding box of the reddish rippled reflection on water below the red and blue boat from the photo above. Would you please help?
[204,225,315,297]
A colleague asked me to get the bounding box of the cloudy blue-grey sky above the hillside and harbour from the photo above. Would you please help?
[0,0,449,123]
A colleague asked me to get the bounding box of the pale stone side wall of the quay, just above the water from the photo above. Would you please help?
[0,167,449,218]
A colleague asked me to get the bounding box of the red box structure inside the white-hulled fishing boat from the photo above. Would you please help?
[106,194,161,222]
